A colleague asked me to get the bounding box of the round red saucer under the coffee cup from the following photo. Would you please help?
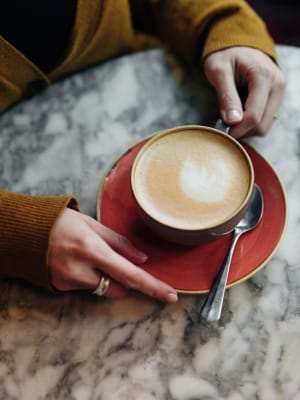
[97,139,287,293]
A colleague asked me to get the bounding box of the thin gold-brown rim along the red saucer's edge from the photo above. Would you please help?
[96,133,288,295]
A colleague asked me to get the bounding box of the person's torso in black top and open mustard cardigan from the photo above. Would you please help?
[0,0,134,112]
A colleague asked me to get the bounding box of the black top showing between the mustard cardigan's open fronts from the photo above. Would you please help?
[0,0,77,72]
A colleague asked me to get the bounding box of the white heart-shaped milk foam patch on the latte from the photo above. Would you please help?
[179,159,231,202]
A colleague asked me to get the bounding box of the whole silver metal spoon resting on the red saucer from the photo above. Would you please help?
[197,184,264,322]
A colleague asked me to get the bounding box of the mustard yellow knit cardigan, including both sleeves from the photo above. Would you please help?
[0,0,275,289]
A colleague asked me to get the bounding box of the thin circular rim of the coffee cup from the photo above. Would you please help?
[130,124,254,232]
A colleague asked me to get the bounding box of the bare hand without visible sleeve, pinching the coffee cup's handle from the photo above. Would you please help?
[204,47,285,138]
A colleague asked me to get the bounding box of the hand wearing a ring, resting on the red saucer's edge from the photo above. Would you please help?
[48,208,177,303]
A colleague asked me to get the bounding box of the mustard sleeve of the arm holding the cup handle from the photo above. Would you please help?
[132,0,276,65]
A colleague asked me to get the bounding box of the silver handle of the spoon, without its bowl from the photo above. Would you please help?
[198,230,241,322]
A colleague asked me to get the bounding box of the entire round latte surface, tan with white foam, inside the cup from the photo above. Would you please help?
[134,129,250,230]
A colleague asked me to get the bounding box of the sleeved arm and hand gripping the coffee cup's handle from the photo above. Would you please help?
[131,0,285,138]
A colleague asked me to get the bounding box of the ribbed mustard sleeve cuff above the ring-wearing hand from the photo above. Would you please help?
[0,191,78,290]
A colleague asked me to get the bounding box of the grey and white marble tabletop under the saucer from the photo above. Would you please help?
[0,46,300,400]
